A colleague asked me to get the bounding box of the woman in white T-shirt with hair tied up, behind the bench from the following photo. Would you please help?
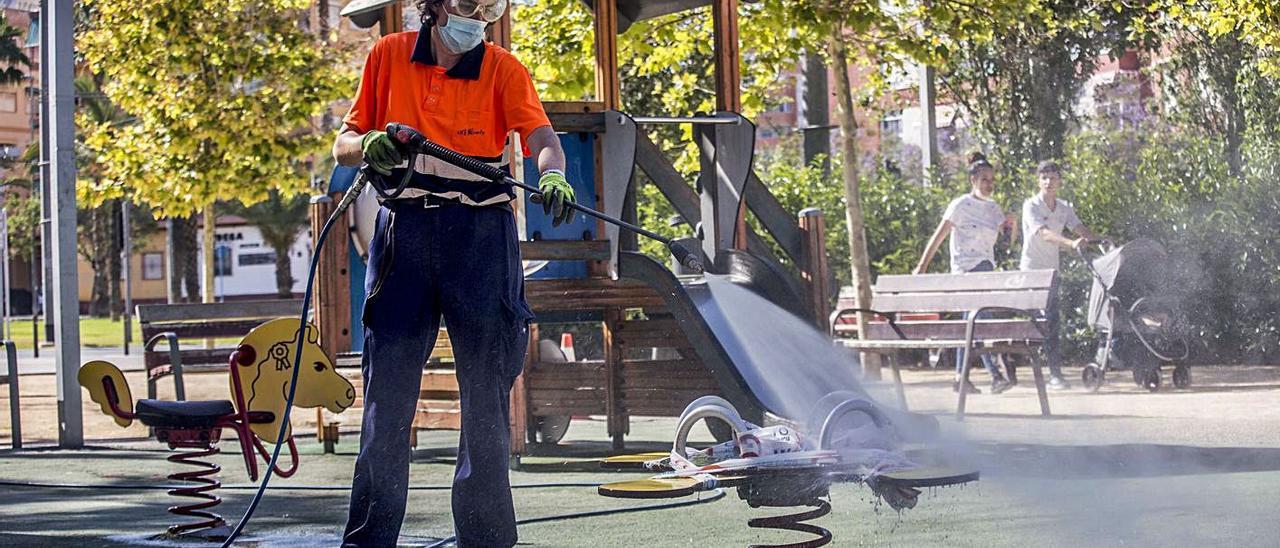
[913,152,1016,394]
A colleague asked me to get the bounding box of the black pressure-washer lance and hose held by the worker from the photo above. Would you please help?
[223,123,703,548]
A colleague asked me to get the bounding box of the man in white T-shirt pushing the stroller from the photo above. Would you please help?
[1018,161,1098,391]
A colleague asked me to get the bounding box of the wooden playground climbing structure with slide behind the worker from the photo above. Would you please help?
[311,0,832,458]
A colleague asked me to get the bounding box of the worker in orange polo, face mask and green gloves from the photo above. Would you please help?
[333,0,573,547]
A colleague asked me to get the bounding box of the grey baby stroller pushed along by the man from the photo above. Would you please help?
[1080,239,1192,392]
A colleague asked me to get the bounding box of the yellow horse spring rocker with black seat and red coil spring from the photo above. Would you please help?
[78,318,356,539]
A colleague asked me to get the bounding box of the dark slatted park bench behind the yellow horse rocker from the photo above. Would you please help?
[137,300,302,401]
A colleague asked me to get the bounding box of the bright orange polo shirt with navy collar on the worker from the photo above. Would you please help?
[343,31,550,204]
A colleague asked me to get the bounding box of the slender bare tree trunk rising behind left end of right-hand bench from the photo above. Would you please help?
[829,28,881,379]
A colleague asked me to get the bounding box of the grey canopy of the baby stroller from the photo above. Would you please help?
[1088,239,1169,330]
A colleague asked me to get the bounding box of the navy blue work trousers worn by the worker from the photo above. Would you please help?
[343,200,532,547]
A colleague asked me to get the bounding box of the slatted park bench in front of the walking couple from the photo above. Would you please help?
[831,270,1057,419]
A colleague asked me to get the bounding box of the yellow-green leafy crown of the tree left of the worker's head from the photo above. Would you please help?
[78,0,353,216]
